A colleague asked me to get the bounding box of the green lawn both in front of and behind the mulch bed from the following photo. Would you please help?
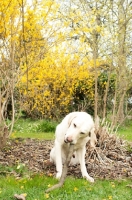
[0,119,132,200]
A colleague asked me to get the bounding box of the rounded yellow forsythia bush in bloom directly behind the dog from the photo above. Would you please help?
[19,52,94,119]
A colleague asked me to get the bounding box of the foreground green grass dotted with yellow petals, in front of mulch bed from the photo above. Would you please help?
[0,175,132,200]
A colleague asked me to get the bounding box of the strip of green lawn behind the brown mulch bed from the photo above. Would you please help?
[11,119,132,141]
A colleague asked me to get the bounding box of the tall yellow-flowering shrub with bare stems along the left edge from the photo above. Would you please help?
[0,0,60,146]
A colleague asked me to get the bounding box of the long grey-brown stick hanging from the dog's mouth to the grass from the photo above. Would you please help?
[46,145,74,193]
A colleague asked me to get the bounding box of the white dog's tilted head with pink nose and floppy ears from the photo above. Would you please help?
[64,112,96,146]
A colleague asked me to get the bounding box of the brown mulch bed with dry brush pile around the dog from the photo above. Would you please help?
[0,123,132,179]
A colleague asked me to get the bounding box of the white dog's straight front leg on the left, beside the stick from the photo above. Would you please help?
[55,141,62,179]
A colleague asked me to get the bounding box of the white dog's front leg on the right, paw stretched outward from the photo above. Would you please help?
[77,147,94,182]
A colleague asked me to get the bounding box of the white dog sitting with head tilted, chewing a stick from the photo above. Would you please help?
[50,112,96,182]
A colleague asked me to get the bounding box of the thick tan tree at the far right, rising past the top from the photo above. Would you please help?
[116,0,132,122]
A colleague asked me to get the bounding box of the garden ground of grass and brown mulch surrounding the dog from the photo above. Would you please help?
[0,119,132,200]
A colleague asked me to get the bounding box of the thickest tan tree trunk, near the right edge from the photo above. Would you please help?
[117,0,127,123]
